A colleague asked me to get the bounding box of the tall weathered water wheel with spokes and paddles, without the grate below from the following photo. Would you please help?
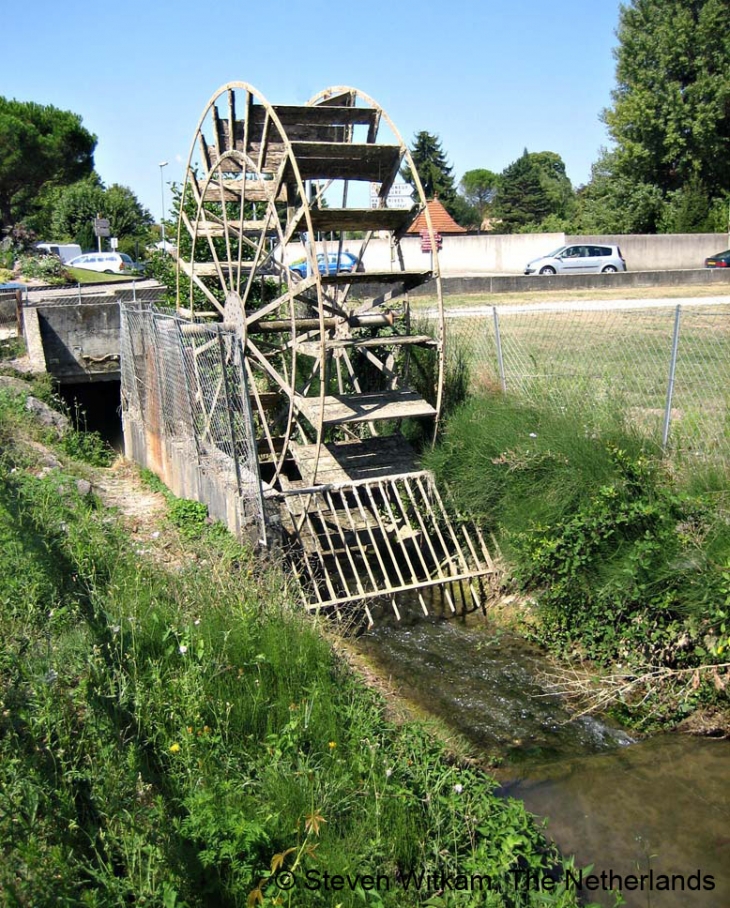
[177,82,444,485]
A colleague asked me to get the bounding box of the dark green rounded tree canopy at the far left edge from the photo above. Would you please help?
[0,97,96,227]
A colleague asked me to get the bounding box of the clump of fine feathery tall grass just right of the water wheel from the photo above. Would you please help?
[425,393,658,553]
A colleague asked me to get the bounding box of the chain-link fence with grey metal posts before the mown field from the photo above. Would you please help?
[438,302,730,463]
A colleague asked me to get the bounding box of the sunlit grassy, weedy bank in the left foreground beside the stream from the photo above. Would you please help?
[0,378,592,908]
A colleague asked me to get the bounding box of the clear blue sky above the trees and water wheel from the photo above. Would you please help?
[0,0,619,220]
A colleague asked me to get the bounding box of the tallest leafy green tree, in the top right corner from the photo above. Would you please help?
[603,0,730,216]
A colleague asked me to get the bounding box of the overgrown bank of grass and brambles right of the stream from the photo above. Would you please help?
[429,394,730,726]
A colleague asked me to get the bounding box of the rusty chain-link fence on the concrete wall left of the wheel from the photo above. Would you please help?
[121,301,265,540]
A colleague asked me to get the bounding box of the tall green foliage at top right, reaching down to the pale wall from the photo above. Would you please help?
[577,0,730,232]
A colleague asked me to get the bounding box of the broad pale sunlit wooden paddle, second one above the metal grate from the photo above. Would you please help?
[294,390,436,426]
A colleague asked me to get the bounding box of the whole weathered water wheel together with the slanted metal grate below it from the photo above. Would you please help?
[178,82,494,616]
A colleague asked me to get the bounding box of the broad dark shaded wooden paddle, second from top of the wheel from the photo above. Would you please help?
[285,142,401,183]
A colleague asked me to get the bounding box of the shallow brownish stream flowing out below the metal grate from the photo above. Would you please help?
[358,616,730,908]
